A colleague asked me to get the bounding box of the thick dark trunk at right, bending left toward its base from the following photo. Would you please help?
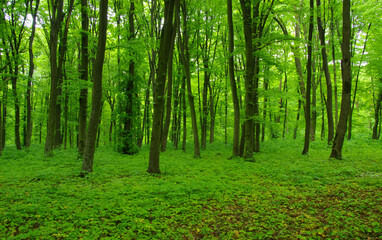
[330,0,351,159]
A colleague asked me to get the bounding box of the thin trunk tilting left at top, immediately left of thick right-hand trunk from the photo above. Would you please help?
[316,0,334,143]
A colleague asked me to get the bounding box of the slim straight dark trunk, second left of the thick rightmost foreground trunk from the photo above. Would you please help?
[302,0,314,154]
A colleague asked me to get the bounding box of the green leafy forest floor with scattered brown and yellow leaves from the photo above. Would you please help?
[0,140,382,239]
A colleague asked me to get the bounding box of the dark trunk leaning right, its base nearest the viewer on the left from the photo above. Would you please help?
[81,0,108,175]
